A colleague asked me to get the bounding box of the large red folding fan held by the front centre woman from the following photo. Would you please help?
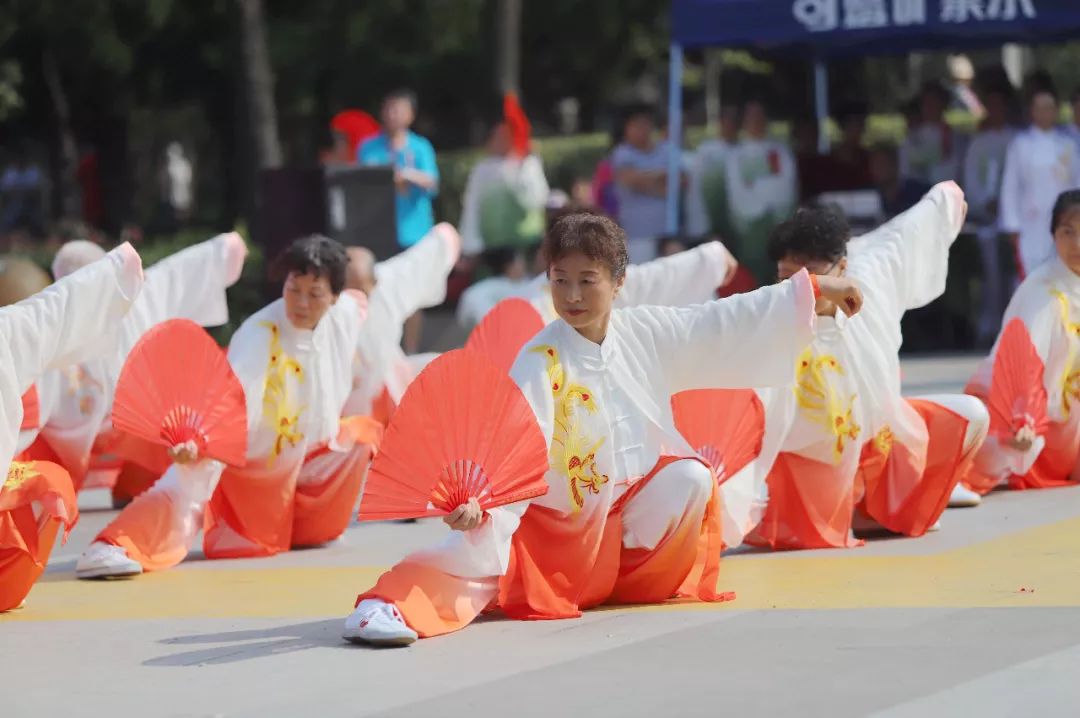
[360,350,548,520]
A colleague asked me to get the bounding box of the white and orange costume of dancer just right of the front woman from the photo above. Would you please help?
[743,182,989,548]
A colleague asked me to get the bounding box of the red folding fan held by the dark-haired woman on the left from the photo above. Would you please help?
[112,320,247,466]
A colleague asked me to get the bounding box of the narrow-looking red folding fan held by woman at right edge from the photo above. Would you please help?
[987,319,1050,439]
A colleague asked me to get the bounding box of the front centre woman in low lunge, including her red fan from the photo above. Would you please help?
[343,214,862,645]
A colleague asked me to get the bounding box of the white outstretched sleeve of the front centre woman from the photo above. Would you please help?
[635,270,815,394]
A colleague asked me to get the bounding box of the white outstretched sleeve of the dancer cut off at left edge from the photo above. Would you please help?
[0,243,143,466]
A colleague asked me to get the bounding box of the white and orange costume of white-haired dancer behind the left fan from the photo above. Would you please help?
[19,233,247,496]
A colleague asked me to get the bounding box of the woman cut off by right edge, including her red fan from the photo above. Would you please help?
[968,190,1080,493]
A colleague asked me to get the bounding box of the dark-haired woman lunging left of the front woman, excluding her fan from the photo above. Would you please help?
[76,236,377,579]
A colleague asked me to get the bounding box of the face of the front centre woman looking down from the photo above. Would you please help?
[548,252,622,341]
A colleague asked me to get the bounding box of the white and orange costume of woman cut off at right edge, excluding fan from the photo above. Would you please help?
[968,253,1080,493]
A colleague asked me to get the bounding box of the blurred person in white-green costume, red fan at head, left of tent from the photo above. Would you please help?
[461,113,550,255]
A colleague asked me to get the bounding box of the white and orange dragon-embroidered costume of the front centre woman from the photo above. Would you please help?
[358,272,814,636]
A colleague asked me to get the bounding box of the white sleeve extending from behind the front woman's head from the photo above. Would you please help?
[618,242,734,307]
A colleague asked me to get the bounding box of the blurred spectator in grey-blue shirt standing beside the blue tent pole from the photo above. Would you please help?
[611,106,672,263]
